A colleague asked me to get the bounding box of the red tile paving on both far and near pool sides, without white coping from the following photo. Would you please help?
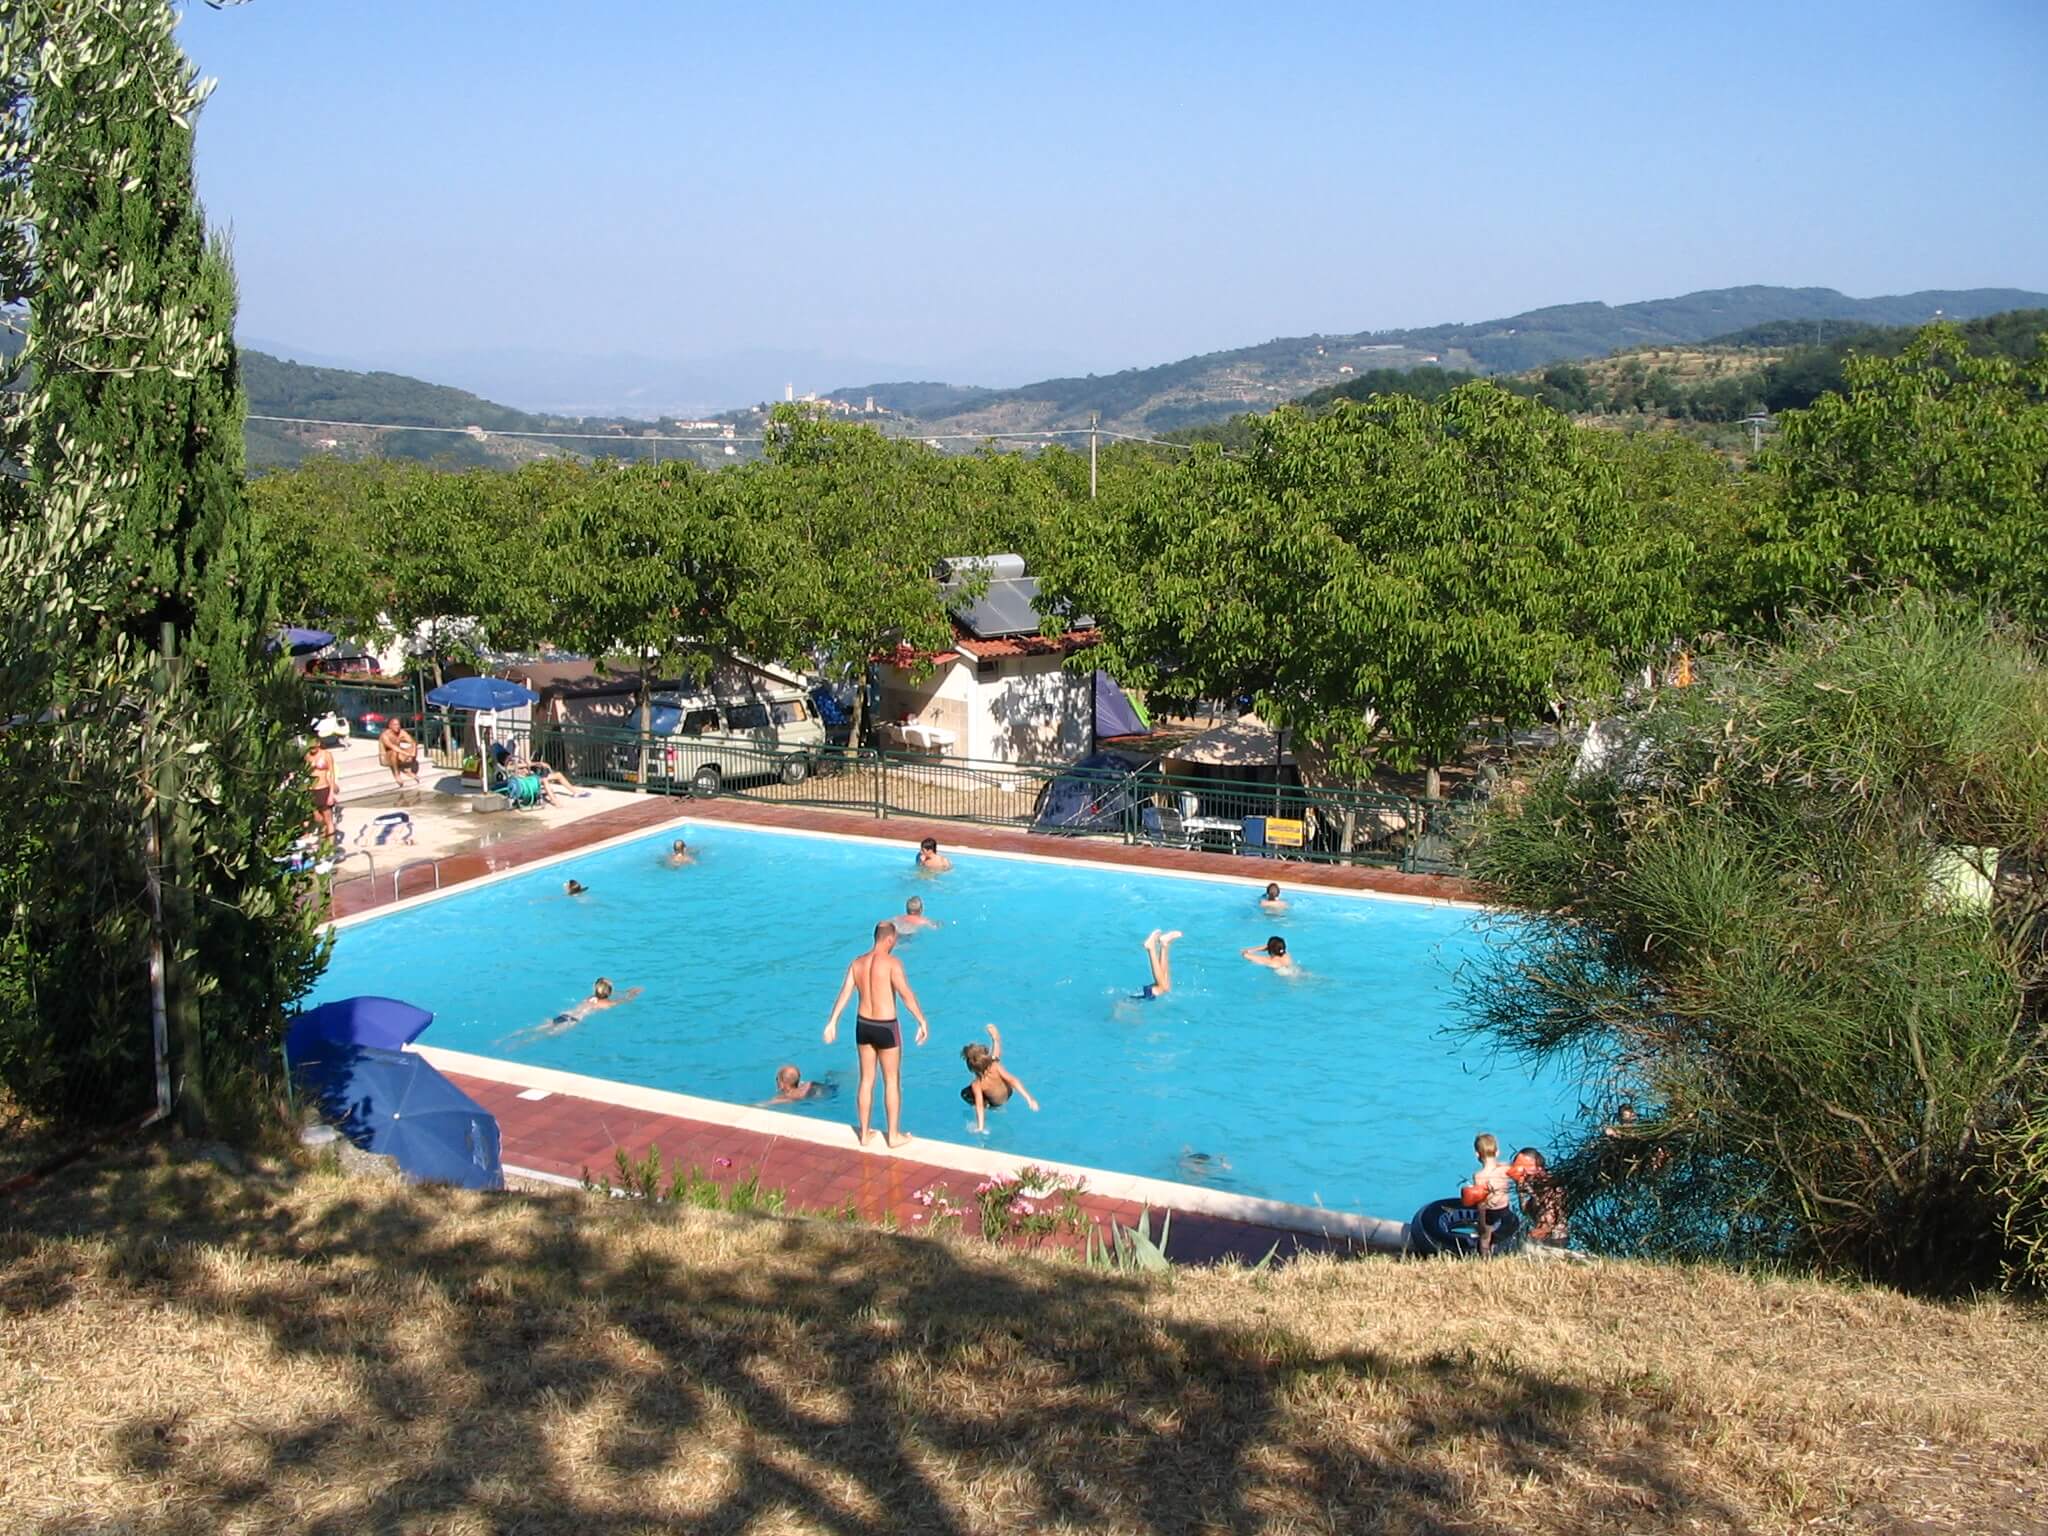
[332,795,1481,1264]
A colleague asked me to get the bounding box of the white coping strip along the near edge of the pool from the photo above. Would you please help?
[408,1048,1407,1253]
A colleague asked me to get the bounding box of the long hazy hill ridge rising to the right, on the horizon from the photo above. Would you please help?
[872,287,2048,432]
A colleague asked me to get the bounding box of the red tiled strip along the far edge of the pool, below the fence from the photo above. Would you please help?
[328,795,1483,918]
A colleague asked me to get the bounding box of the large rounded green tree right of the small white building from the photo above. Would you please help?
[1047,383,1683,793]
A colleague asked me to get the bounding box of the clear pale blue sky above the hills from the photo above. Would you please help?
[182,0,2048,385]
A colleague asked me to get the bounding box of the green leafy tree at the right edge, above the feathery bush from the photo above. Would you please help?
[1743,326,2048,631]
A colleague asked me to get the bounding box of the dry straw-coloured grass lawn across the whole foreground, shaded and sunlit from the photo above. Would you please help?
[0,1151,2048,1536]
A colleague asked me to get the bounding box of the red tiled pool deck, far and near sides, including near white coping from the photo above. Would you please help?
[332,797,1481,1264]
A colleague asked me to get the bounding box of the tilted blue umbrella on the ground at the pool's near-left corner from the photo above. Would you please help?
[293,1040,506,1190]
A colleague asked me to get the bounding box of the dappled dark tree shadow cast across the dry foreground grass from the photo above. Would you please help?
[0,1165,1743,1536]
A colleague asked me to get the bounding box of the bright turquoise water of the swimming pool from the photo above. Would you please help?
[311,825,1567,1219]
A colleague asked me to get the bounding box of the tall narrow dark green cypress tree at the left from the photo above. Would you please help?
[0,0,319,1124]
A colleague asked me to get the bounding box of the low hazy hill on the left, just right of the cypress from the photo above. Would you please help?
[242,348,679,471]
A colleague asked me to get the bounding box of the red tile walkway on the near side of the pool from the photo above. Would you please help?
[449,1073,1358,1264]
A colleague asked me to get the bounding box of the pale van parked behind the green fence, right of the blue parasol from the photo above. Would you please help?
[610,688,825,795]
